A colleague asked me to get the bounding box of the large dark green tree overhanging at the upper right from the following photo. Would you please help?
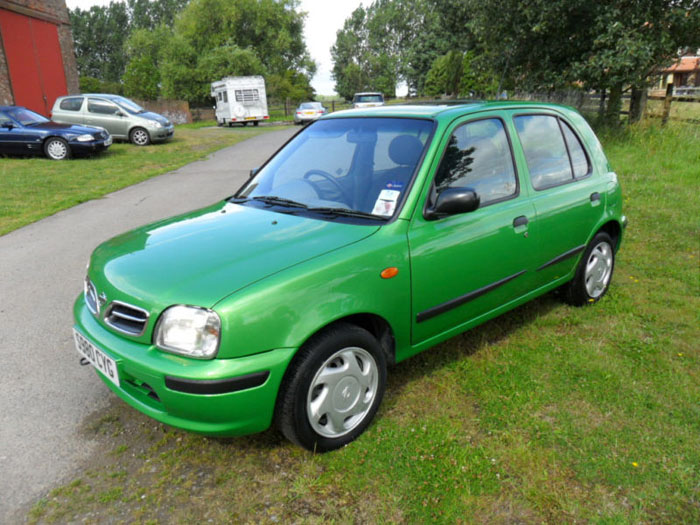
[469,0,700,122]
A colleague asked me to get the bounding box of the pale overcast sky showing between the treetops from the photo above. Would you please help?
[66,0,372,95]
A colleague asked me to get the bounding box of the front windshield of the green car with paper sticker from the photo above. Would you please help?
[236,118,433,220]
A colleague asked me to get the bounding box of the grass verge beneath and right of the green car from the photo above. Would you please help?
[28,124,700,524]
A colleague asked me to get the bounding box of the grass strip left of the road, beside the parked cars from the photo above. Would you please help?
[0,124,280,235]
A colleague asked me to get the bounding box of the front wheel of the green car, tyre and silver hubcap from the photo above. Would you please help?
[275,323,386,452]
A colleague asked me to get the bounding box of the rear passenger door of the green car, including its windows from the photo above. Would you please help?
[513,112,605,288]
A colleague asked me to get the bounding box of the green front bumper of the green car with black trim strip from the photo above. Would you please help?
[73,295,296,436]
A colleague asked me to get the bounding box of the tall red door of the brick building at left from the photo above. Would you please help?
[0,9,68,116]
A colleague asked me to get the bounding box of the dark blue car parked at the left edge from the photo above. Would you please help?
[0,106,112,160]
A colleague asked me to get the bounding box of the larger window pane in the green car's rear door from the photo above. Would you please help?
[514,115,573,190]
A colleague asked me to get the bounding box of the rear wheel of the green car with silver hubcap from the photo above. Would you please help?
[562,232,615,306]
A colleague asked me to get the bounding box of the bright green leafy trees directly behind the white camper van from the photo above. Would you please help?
[125,0,316,103]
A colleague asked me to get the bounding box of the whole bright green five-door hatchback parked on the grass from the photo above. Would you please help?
[74,102,626,451]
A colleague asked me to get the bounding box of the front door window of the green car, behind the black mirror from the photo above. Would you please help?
[435,118,518,206]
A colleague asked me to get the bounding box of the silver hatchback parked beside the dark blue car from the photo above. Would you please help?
[51,93,175,146]
